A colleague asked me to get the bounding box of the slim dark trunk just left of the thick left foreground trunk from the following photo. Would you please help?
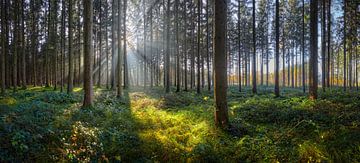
[67,0,74,93]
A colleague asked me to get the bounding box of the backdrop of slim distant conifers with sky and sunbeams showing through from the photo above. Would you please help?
[0,0,359,104]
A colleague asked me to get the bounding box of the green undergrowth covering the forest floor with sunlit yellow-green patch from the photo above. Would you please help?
[0,87,360,162]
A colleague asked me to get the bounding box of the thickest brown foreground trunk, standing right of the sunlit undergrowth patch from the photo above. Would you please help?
[213,1,229,129]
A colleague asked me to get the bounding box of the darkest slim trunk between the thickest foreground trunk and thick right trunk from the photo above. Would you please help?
[275,0,280,97]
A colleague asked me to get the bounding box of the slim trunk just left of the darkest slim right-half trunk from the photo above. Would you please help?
[252,0,257,94]
